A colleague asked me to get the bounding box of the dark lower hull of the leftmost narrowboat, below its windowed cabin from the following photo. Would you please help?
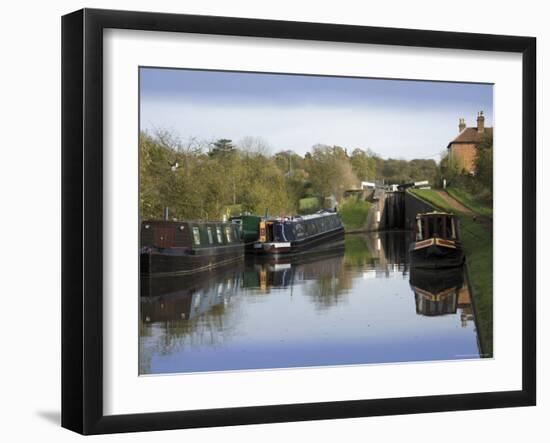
[140,243,244,276]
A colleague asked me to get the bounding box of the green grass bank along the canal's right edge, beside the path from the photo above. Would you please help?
[410,189,493,357]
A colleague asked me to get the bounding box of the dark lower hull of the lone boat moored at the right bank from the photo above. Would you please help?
[409,238,464,269]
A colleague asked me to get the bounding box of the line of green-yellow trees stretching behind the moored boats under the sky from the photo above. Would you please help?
[140,131,474,225]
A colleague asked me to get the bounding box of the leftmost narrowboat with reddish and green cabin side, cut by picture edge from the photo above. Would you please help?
[140,220,244,276]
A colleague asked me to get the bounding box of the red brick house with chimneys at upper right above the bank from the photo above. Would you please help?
[447,111,493,174]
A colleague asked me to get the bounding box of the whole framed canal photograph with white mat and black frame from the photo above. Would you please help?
[62,9,537,434]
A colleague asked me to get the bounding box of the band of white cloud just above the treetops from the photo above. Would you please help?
[141,100,492,160]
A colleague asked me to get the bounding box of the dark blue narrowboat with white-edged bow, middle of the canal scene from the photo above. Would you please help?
[253,211,344,255]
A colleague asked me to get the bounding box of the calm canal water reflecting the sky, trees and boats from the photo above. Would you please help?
[139,232,480,374]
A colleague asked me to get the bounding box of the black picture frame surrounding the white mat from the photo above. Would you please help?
[62,9,537,434]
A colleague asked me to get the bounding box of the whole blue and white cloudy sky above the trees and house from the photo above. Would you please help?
[140,68,493,160]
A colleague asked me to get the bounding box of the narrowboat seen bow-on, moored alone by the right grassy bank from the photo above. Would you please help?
[409,211,464,269]
